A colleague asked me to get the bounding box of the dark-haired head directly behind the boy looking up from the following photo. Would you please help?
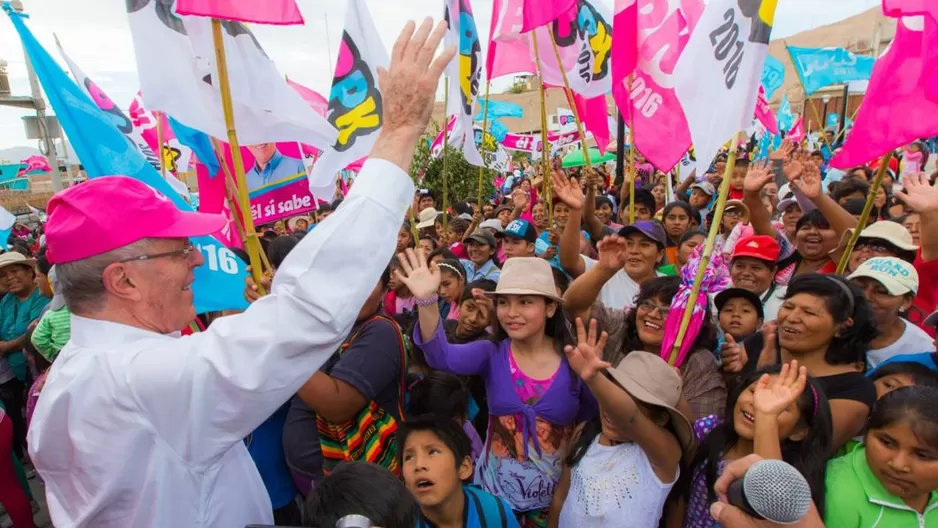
[408,372,482,462]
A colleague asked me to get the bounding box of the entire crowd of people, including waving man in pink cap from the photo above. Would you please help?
[0,14,938,528]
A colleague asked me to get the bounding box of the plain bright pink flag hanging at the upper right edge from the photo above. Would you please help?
[831,13,938,169]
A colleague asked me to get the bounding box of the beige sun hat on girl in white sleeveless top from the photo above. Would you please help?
[606,351,695,451]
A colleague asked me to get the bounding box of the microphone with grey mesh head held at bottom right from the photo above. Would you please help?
[726,460,812,524]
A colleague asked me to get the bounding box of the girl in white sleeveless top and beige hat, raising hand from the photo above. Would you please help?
[551,319,694,528]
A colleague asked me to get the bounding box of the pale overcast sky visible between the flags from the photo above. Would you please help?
[0,0,880,156]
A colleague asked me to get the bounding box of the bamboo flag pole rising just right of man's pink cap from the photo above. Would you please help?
[213,18,265,295]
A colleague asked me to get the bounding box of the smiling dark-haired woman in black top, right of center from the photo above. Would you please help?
[724,273,877,449]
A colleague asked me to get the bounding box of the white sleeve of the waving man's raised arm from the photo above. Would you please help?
[124,159,414,462]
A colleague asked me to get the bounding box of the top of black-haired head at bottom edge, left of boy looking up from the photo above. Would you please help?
[304,462,420,528]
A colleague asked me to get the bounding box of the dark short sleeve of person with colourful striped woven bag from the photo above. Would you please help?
[329,320,403,401]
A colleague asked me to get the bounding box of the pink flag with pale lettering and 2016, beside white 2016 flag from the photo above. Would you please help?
[612,0,704,170]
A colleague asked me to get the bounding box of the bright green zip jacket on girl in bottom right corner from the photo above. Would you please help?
[824,446,938,528]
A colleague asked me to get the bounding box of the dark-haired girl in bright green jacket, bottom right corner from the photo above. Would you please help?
[818,386,938,528]
